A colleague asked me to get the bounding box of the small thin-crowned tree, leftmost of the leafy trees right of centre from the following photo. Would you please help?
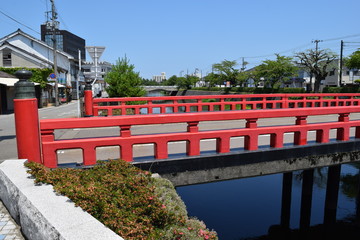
[212,59,239,85]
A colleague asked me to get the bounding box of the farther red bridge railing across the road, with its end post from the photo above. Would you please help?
[85,93,360,116]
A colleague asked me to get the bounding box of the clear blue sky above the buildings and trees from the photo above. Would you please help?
[0,0,360,78]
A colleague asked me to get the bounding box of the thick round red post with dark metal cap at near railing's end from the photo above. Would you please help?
[14,70,42,163]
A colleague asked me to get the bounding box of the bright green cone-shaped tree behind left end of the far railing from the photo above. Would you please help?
[105,56,146,97]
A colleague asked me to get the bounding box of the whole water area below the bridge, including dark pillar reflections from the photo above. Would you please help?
[177,164,360,240]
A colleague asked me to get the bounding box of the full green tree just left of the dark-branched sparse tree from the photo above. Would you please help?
[256,54,298,88]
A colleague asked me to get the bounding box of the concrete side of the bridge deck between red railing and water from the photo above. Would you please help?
[134,140,360,186]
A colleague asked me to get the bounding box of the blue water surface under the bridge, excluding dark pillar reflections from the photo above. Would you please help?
[177,164,360,240]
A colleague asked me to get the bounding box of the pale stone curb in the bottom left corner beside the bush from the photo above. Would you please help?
[0,160,123,240]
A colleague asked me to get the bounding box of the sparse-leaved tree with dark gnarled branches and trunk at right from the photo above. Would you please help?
[295,49,337,92]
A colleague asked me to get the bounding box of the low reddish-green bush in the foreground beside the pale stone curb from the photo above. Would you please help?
[26,160,217,240]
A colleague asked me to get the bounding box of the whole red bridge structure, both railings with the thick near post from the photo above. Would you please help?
[15,89,360,180]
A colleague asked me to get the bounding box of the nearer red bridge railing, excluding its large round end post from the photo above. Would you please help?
[40,106,360,168]
